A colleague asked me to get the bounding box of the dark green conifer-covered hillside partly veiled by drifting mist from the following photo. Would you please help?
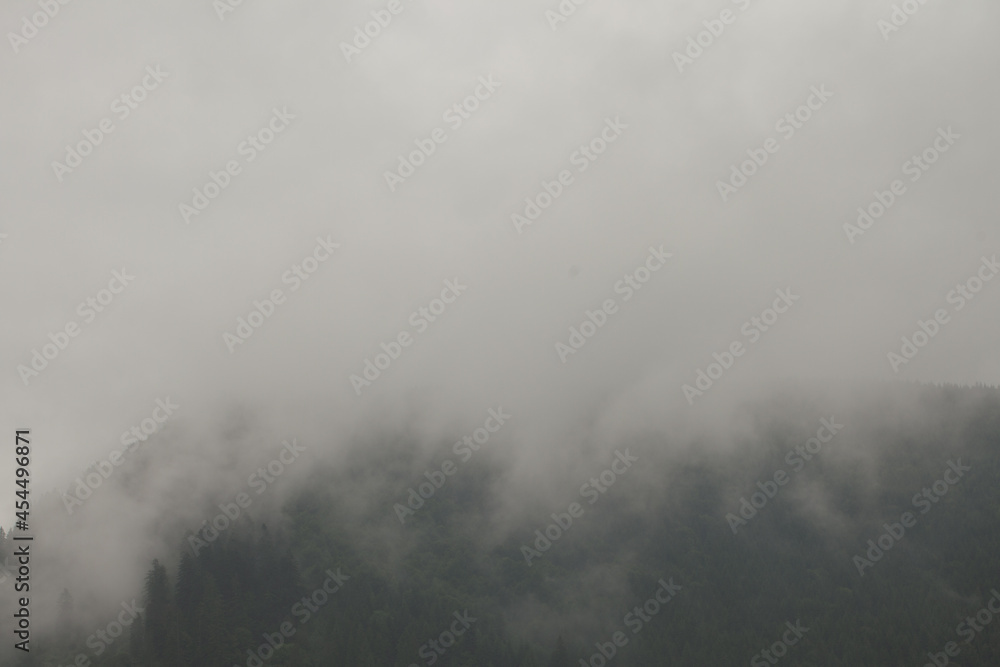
[0,386,1000,667]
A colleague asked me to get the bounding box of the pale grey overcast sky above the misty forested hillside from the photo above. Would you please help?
[0,0,1000,628]
